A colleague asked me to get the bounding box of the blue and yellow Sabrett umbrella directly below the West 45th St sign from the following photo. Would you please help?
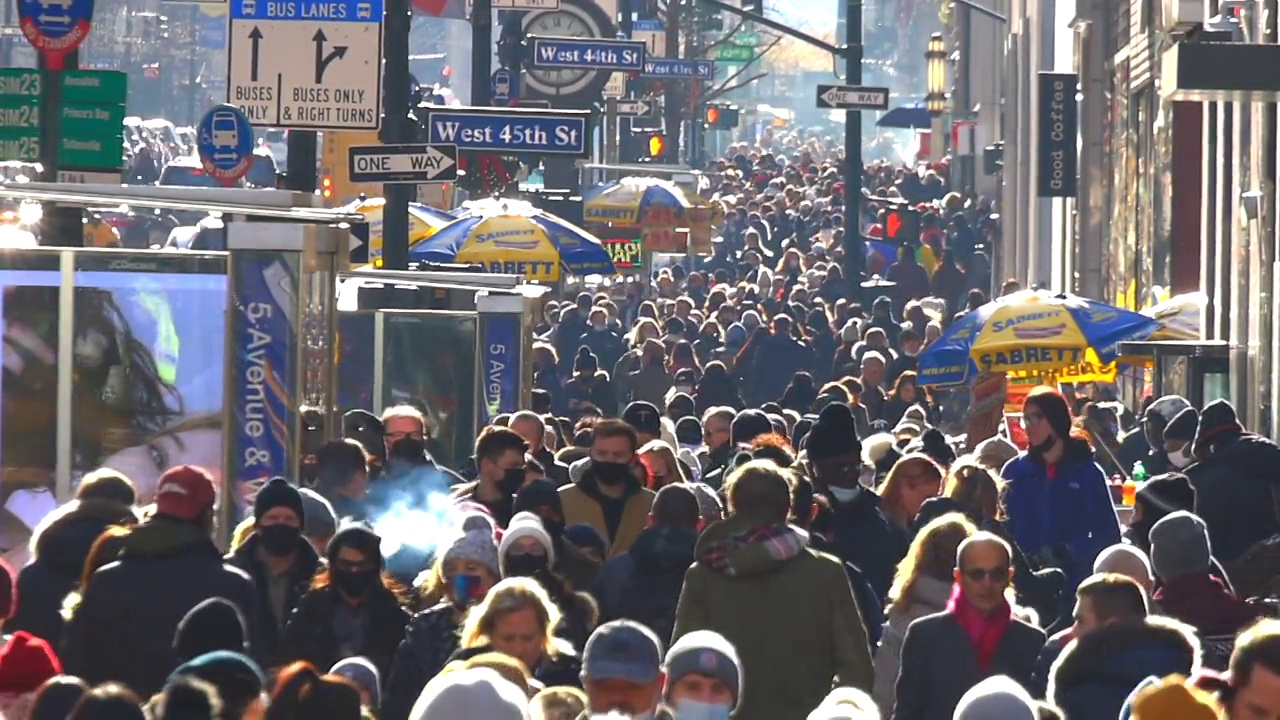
[408,204,617,282]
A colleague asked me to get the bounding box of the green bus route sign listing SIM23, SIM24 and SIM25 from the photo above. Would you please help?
[0,68,128,172]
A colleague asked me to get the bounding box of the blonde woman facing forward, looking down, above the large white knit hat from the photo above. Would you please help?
[452,578,582,687]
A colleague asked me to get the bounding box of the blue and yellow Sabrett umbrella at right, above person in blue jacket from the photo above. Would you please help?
[919,290,1158,386]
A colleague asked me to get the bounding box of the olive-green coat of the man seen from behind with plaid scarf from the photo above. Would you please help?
[671,515,873,720]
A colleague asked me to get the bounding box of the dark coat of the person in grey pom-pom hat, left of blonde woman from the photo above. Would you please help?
[379,602,461,720]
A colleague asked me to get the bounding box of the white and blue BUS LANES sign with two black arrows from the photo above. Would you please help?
[227,0,383,129]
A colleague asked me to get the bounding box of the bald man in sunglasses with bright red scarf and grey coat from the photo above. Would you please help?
[892,532,1044,720]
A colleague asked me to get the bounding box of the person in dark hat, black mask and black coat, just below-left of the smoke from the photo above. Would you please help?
[279,525,410,678]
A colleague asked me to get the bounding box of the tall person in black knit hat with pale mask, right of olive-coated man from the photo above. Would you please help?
[804,402,910,597]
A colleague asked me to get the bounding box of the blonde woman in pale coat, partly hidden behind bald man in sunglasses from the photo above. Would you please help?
[872,512,978,719]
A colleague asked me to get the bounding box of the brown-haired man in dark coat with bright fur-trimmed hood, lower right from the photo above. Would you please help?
[1047,574,1201,719]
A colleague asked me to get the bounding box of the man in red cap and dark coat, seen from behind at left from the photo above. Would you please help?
[60,465,256,697]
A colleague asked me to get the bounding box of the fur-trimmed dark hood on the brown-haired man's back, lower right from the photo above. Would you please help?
[1048,615,1201,705]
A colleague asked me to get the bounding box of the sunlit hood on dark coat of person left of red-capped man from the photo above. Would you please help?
[29,500,138,580]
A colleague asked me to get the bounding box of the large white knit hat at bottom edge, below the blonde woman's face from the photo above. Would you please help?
[408,667,529,720]
